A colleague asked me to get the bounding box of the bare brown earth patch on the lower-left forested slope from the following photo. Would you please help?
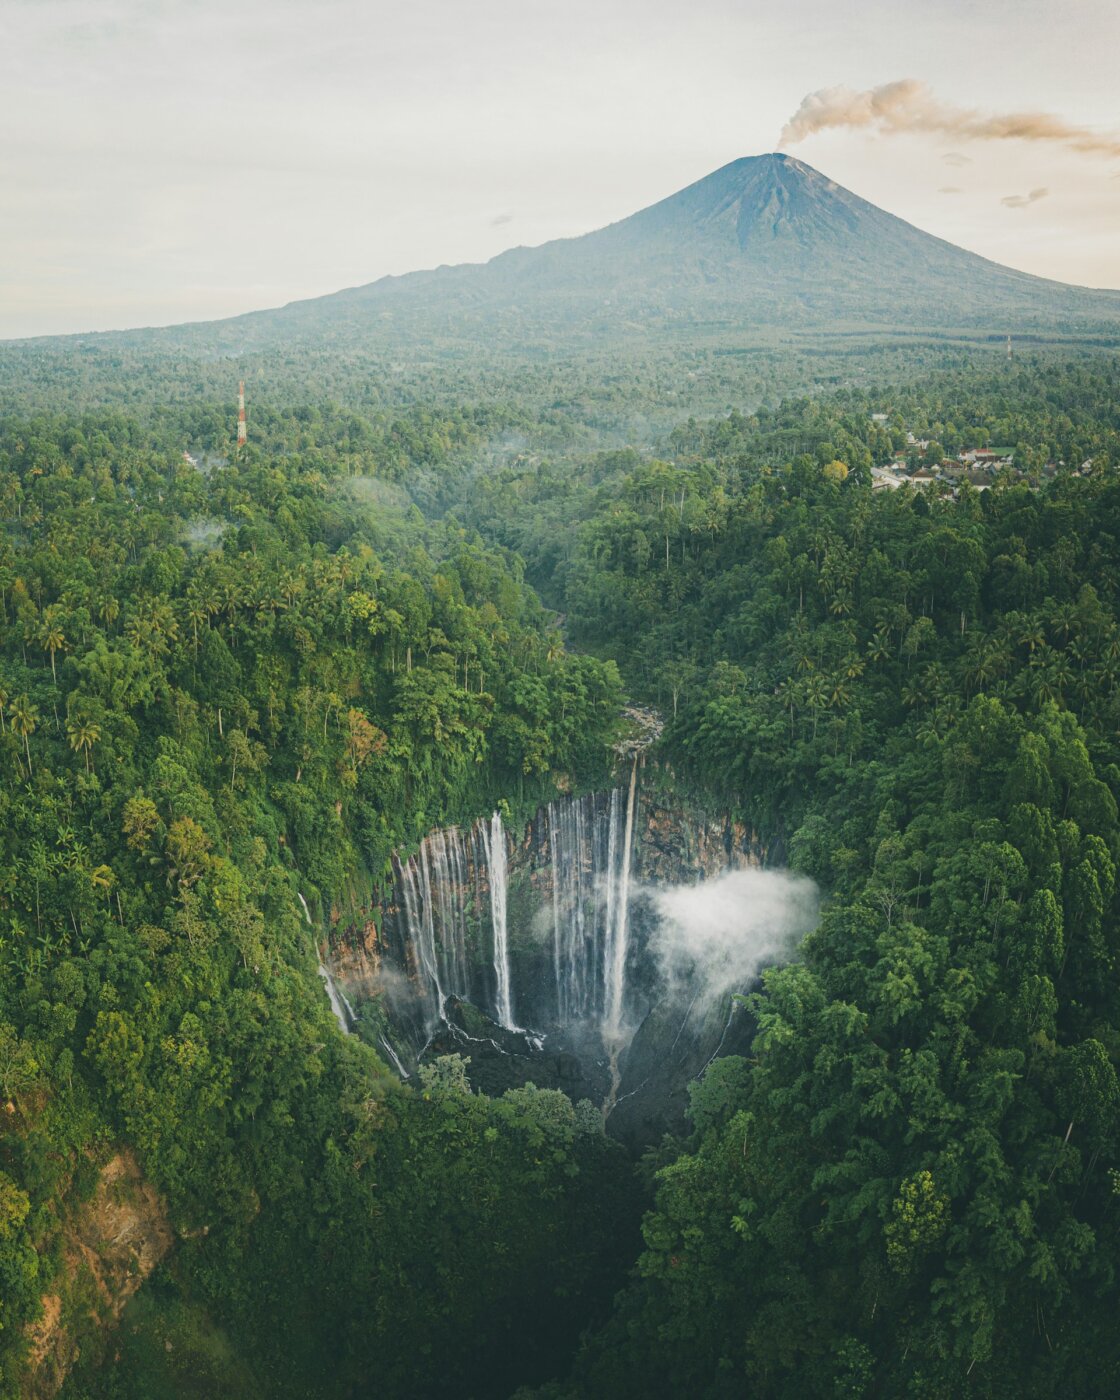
[24,1149,174,1400]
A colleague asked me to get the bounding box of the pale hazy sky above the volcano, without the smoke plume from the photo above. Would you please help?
[0,0,1120,336]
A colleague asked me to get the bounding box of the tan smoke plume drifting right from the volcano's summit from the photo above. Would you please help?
[781,78,1120,164]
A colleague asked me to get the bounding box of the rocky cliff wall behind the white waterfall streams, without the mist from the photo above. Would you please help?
[319,770,771,1145]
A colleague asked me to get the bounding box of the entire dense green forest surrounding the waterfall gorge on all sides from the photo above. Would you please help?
[0,356,1120,1400]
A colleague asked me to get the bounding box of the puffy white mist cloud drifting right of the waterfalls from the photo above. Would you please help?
[645,869,820,998]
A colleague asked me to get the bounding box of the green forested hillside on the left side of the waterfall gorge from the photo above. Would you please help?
[0,417,627,1396]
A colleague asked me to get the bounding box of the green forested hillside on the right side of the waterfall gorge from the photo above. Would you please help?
[479,368,1120,1397]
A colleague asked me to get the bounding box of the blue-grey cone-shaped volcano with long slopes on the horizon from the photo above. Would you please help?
[8,154,1120,353]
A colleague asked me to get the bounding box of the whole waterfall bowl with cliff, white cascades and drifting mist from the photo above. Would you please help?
[329,789,818,1141]
